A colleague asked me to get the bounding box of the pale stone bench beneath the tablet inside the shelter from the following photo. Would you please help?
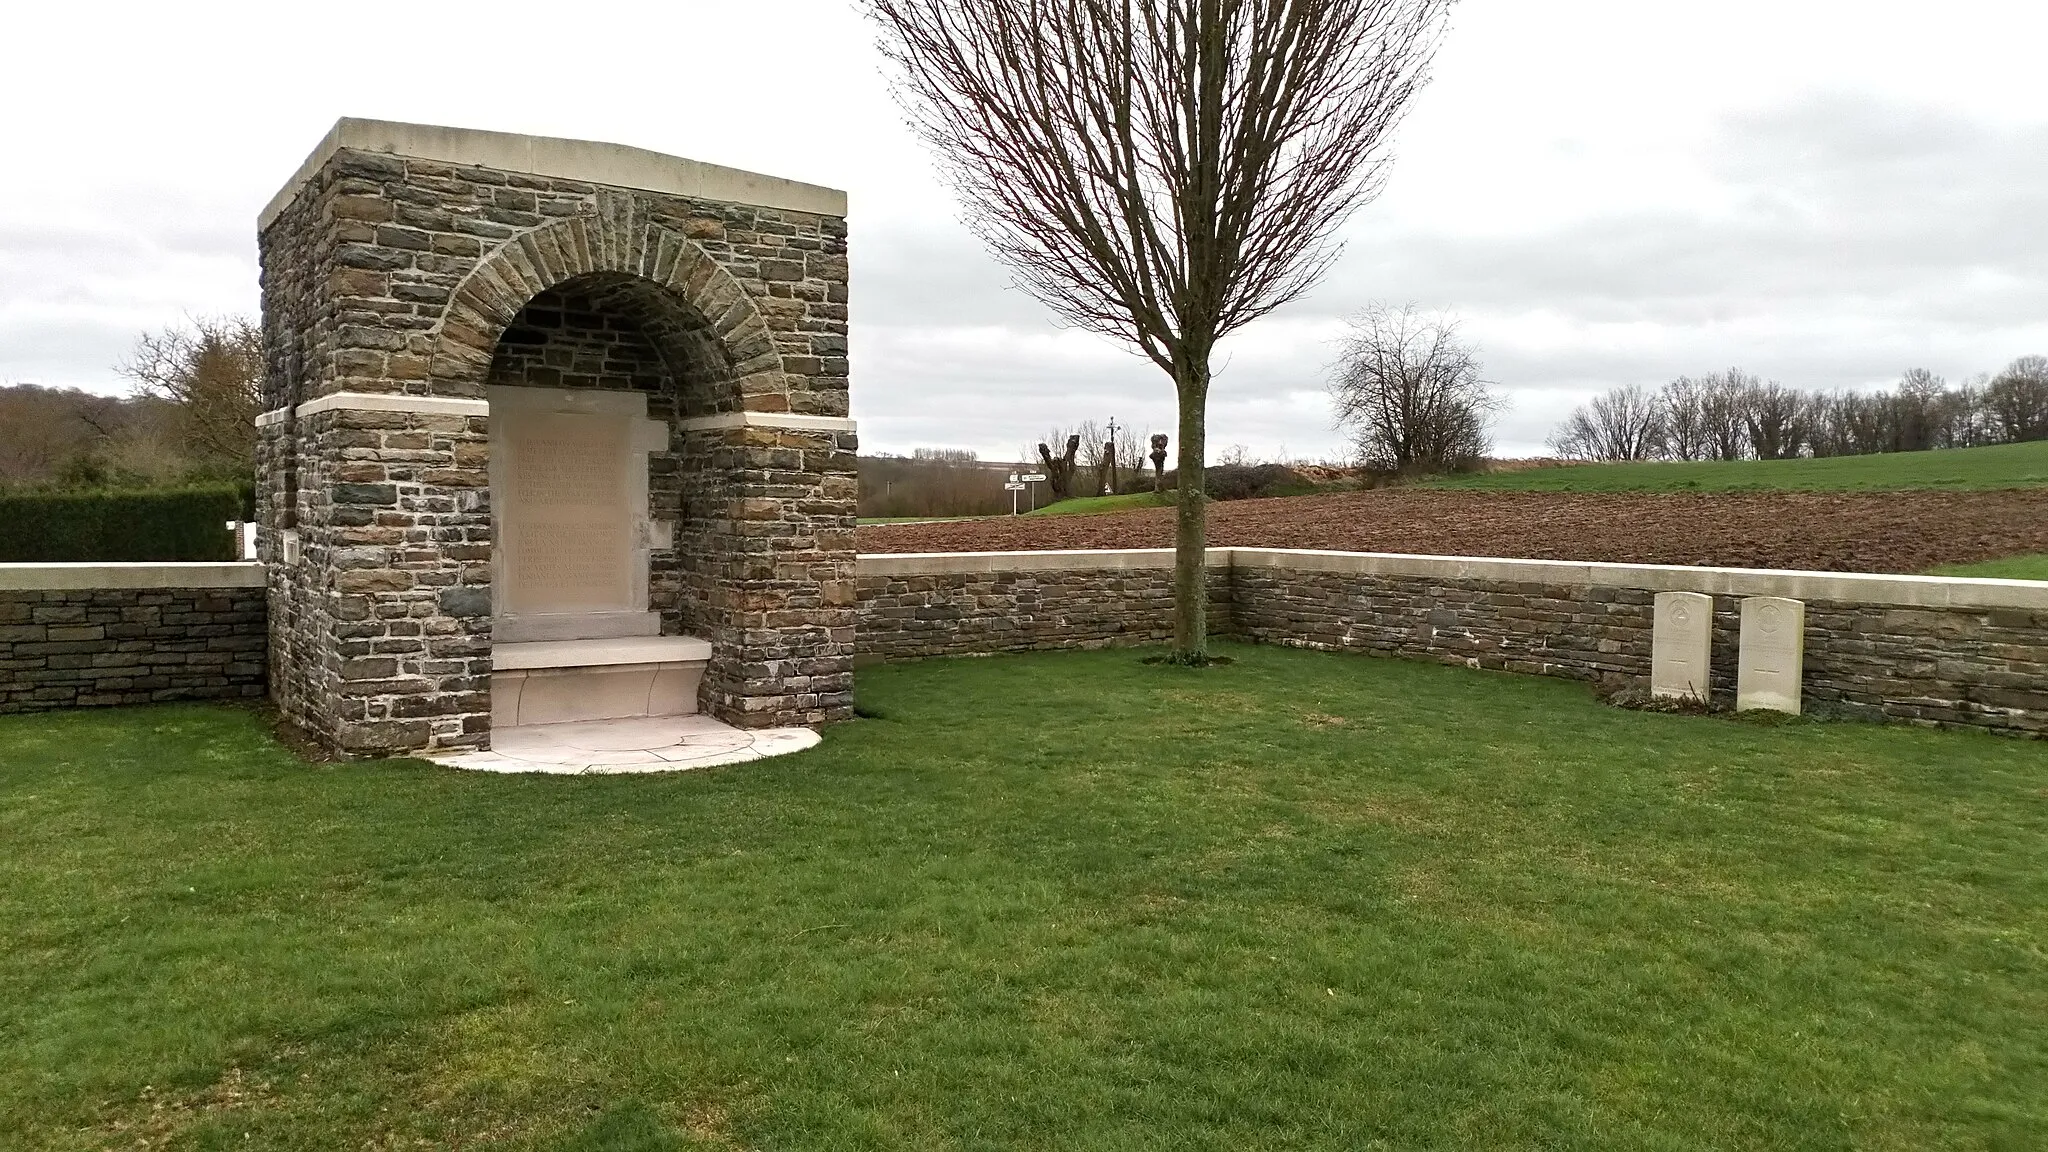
[492,635,711,728]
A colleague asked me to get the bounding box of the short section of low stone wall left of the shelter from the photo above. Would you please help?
[0,564,264,713]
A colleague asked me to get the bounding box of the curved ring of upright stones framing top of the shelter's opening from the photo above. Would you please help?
[428,195,786,416]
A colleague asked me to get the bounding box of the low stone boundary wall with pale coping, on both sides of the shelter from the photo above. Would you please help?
[0,547,2048,736]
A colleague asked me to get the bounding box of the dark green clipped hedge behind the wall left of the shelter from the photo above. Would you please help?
[0,484,252,564]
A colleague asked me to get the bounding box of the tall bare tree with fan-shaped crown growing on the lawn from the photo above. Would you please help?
[864,0,1450,664]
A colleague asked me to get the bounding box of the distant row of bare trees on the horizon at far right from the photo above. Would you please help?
[1550,357,2048,461]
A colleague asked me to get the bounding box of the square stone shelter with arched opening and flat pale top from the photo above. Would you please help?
[258,119,856,754]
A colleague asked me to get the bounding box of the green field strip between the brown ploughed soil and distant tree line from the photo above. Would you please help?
[1425,441,2048,492]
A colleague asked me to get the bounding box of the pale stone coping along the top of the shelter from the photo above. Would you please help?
[256,117,846,232]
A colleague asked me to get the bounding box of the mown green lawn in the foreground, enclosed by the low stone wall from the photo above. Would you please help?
[0,646,2048,1150]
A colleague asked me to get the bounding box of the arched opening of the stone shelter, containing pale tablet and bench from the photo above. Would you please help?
[485,273,733,726]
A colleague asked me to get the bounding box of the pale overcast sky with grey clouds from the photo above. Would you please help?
[0,0,2048,459]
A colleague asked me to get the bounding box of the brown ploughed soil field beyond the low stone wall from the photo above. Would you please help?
[860,488,2048,572]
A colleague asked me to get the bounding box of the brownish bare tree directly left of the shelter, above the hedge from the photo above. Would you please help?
[119,316,262,480]
